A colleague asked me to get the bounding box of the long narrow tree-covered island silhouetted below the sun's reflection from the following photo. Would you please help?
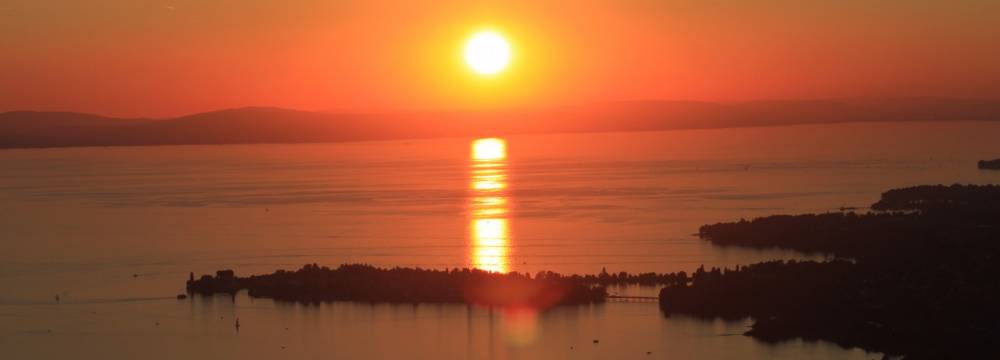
[187,264,608,308]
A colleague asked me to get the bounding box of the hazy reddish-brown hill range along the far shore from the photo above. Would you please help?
[0,98,1000,148]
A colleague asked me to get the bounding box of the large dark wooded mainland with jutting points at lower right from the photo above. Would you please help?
[660,186,1000,358]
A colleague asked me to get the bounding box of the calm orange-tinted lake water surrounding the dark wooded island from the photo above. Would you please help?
[0,122,1000,359]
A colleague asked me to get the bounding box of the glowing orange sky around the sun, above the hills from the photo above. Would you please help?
[0,0,1000,117]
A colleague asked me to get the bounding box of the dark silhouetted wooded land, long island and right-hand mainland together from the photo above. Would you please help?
[187,185,1000,359]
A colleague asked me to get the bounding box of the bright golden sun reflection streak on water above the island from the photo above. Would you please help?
[469,138,510,273]
